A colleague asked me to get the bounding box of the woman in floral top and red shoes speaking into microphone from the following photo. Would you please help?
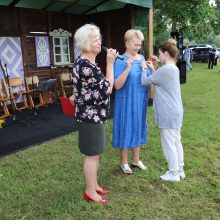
[73,24,118,203]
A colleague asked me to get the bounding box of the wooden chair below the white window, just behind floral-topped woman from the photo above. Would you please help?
[59,73,73,98]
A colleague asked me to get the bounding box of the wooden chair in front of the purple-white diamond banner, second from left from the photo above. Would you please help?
[9,77,30,111]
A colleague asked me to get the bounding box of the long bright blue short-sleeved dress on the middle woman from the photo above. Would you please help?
[112,55,150,149]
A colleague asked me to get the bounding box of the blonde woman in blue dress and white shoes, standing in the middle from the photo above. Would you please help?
[112,29,150,174]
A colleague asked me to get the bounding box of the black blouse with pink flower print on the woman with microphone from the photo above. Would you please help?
[72,57,110,124]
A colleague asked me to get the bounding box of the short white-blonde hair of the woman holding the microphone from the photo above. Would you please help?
[74,24,101,52]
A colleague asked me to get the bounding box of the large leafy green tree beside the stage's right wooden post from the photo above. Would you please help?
[153,0,216,39]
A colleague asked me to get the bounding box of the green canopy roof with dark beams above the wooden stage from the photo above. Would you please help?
[0,0,152,14]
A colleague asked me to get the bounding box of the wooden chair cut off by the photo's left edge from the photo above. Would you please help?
[0,79,10,119]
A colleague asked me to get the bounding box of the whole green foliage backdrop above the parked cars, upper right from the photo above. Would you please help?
[153,0,220,47]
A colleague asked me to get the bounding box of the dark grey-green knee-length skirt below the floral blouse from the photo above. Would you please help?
[77,122,106,156]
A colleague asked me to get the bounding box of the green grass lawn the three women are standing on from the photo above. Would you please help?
[0,63,220,220]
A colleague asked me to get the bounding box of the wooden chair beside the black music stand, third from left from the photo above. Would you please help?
[25,76,45,108]
